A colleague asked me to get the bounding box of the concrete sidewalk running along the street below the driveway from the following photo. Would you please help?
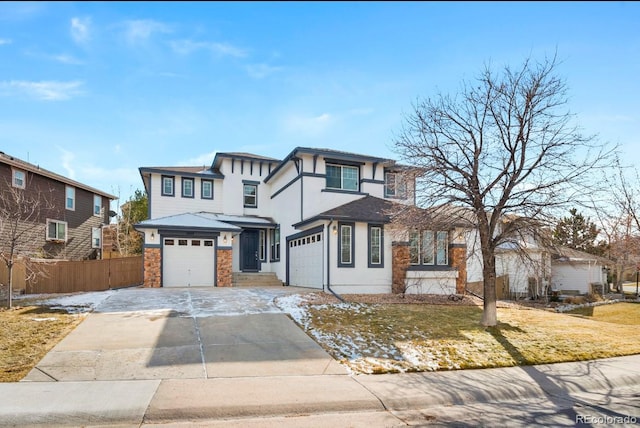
[0,355,640,427]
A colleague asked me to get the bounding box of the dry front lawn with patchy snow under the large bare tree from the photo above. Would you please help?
[282,303,640,373]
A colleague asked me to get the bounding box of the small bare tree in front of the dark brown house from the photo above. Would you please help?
[0,179,55,308]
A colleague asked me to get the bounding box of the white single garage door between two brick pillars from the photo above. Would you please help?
[162,238,216,287]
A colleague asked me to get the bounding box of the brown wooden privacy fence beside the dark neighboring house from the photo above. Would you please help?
[0,256,143,294]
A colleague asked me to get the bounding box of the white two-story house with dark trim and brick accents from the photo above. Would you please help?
[136,147,466,293]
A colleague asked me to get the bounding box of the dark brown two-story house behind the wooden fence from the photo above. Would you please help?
[0,152,116,260]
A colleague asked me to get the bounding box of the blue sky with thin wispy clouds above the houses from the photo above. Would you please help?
[0,2,640,209]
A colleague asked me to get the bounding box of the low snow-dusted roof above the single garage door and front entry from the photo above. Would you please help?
[134,212,275,232]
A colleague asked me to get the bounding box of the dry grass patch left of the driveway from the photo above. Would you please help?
[0,306,84,382]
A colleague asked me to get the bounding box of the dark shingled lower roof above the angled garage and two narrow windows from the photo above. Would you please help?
[293,196,399,229]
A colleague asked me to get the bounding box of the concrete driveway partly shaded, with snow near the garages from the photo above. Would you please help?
[24,287,347,382]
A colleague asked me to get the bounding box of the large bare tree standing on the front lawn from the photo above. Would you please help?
[394,57,612,326]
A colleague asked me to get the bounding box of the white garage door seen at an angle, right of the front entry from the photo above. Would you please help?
[289,232,324,289]
